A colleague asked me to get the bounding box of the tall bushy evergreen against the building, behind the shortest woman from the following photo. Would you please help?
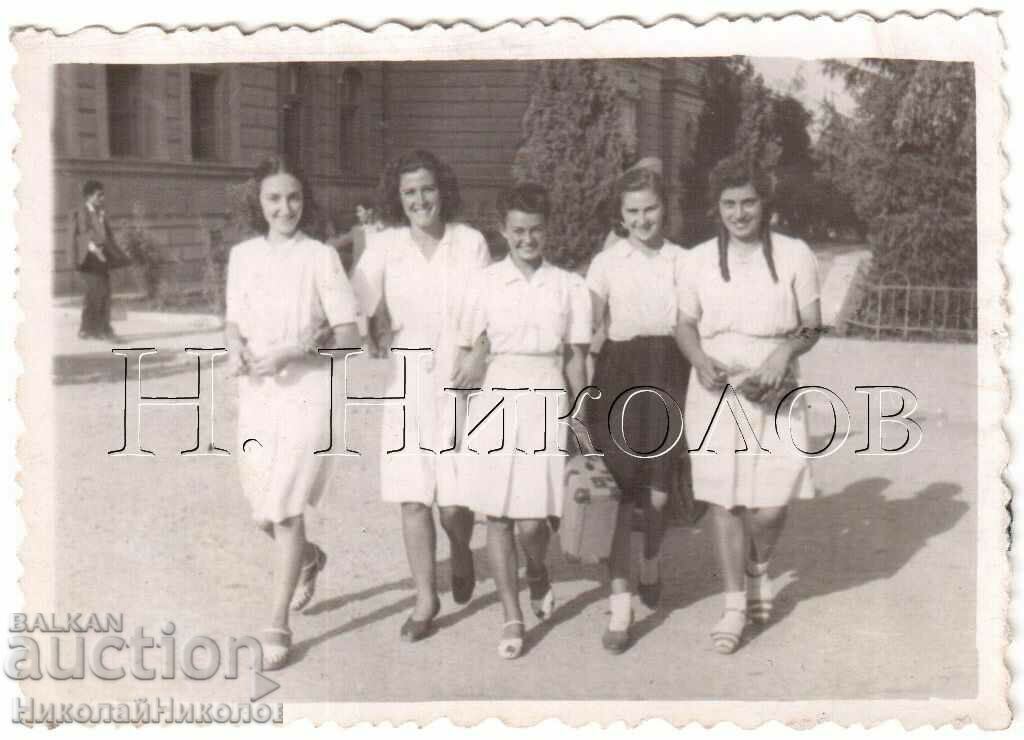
[512,59,633,268]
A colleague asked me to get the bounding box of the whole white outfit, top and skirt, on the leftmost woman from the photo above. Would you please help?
[225,232,356,524]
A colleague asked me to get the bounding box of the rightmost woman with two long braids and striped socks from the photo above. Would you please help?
[677,156,821,653]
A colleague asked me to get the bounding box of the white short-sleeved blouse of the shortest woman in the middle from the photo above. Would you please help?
[459,257,592,354]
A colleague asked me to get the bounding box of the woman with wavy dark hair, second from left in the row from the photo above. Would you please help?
[352,150,490,642]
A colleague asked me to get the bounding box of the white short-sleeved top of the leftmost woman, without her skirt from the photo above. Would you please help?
[225,231,357,354]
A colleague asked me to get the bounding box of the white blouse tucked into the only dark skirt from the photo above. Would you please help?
[587,238,686,342]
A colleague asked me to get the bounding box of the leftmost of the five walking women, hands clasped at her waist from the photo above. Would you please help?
[224,156,359,670]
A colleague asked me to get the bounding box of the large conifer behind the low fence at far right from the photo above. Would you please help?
[817,59,977,286]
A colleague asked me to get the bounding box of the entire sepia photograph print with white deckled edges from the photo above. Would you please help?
[5,8,1010,727]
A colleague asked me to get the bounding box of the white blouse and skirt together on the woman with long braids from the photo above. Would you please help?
[679,233,819,508]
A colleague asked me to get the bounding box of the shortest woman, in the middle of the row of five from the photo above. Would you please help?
[457,183,591,659]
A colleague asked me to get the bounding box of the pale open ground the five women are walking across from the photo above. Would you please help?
[46,300,978,701]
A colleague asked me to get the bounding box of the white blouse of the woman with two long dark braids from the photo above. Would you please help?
[679,232,820,338]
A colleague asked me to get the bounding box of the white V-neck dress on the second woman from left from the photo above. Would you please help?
[352,223,490,506]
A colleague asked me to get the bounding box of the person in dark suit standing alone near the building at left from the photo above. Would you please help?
[71,180,129,340]
